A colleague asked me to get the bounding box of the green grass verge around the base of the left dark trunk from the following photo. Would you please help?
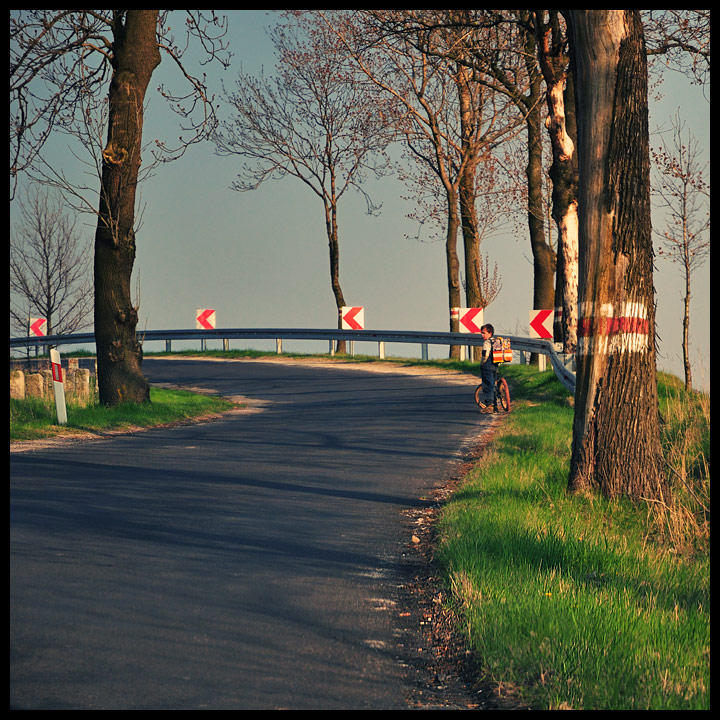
[10,387,233,442]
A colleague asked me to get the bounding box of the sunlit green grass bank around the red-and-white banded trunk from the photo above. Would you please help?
[437,366,710,710]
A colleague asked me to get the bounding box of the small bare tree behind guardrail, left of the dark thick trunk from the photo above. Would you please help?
[10,188,93,342]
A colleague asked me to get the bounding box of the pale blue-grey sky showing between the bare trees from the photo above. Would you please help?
[9,10,710,389]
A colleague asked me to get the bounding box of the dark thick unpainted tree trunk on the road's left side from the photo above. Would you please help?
[94,10,160,405]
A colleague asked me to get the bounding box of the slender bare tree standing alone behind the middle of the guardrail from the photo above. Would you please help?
[215,12,392,353]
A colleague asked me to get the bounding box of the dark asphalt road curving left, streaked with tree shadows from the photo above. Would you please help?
[10,359,487,710]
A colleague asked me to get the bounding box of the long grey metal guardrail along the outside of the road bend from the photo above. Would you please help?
[10,328,575,392]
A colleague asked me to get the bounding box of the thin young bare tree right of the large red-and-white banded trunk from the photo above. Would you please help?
[653,113,710,390]
